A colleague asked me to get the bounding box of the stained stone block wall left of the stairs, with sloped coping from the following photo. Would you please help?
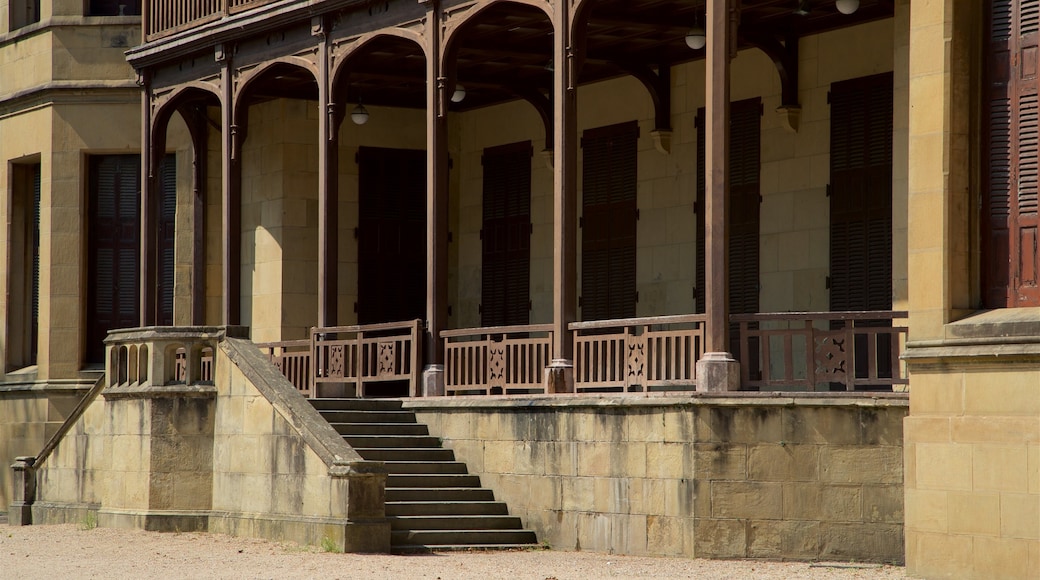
[21,332,390,552]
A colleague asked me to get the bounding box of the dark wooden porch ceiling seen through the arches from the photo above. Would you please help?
[245,0,893,110]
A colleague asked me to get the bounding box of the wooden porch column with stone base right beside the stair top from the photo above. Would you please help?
[422,0,448,396]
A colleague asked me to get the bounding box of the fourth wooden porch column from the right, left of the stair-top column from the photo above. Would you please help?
[311,17,339,326]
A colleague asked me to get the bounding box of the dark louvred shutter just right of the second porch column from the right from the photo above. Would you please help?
[581,121,639,320]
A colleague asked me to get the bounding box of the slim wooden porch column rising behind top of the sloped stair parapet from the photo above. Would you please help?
[216,45,242,325]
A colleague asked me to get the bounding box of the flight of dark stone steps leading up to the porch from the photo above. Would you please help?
[311,399,537,552]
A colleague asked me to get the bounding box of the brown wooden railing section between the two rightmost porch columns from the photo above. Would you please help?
[569,314,705,393]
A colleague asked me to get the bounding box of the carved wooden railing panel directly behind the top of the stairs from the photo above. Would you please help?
[311,320,422,397]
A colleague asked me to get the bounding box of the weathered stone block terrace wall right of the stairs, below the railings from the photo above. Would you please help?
[406,394,908,562]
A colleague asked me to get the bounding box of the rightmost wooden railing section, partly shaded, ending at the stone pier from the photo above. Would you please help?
[730,311,908,391]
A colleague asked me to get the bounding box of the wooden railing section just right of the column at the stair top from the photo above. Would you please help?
[441,324,552,395]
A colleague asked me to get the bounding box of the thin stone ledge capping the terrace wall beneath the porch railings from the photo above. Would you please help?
[404,392,910,411]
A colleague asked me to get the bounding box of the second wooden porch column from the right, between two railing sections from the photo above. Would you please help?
[545,0,578,393]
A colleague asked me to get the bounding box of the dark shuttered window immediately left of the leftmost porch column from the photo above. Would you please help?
[86,155,140,363]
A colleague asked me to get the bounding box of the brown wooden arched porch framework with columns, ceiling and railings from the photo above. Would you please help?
[129,0,906,396]
